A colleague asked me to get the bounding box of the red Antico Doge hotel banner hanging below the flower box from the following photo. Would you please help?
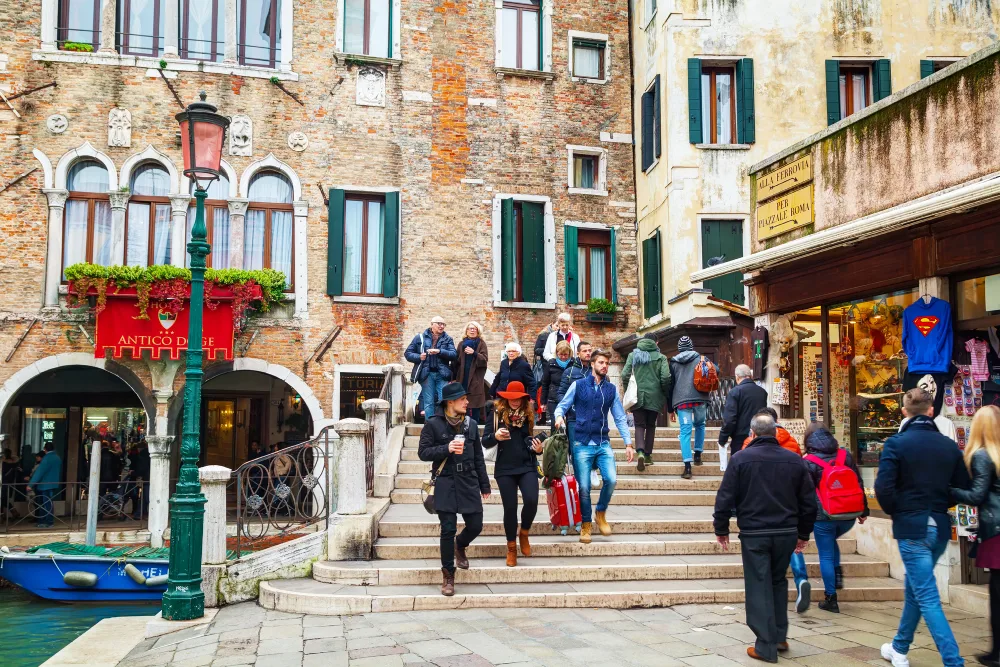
[94,287,233,360]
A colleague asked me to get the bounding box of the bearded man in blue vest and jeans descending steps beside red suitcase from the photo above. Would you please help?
[554,350,635,544]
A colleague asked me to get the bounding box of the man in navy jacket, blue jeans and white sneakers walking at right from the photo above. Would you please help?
[875,388,969,667]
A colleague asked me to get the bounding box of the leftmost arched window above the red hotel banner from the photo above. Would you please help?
[63,160,114,276]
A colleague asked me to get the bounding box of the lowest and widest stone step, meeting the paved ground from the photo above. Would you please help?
[259,577,903,616]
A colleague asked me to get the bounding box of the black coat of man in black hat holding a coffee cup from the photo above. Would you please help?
[417,414,490,514]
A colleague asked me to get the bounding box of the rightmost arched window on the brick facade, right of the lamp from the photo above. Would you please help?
[243,171,294,289]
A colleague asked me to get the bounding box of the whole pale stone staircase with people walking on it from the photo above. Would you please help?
[260,425,903,615]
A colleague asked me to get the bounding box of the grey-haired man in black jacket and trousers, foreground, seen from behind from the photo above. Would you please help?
[713,413,816,662]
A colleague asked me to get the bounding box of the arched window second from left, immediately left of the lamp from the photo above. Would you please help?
[125,162,171,266]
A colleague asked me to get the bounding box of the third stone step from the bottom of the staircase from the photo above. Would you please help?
[375,536,857,565]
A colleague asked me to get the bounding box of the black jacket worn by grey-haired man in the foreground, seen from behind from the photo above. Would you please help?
[713,436,816,540]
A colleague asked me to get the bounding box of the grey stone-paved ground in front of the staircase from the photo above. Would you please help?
[119,602,990,667]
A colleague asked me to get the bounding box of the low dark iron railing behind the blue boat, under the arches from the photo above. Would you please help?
[0,480,149,533]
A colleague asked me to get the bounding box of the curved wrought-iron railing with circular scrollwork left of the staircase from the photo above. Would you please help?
[233,426,336,553]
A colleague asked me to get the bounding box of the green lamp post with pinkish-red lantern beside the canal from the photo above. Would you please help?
[163,93,229,621]
